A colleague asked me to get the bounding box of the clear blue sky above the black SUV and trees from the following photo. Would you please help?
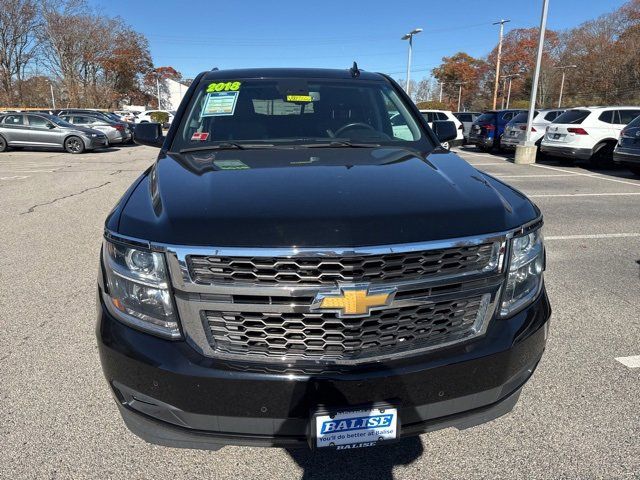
[90,0,625,79]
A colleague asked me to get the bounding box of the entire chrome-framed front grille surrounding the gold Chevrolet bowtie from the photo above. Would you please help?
[165,234,507,366]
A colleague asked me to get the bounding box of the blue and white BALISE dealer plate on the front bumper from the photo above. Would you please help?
[314,408,398,450]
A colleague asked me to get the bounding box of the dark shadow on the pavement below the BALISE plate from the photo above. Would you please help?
[287,437,424,480]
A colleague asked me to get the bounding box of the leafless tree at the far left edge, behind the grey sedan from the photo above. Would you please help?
[0,0,41,105]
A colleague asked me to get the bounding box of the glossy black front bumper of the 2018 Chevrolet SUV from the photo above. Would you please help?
[97,289,551,449]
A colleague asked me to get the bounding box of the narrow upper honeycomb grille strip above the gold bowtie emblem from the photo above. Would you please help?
[187,243,498,285]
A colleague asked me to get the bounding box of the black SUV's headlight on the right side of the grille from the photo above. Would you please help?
[500,228,545,317]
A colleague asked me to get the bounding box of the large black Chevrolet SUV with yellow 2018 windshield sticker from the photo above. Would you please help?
[97,65,551,450]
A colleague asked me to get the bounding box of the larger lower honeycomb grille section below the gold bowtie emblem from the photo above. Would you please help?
[202,294,491,360]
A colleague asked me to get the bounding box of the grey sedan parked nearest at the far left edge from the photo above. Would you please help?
[0,113,108,153]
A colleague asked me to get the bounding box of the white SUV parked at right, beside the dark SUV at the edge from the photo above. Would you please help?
[540,107,640,165]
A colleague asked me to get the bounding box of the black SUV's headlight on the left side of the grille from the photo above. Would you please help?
[103,240,180,338]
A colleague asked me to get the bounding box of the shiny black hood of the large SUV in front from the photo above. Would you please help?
[112,147,539,247]
